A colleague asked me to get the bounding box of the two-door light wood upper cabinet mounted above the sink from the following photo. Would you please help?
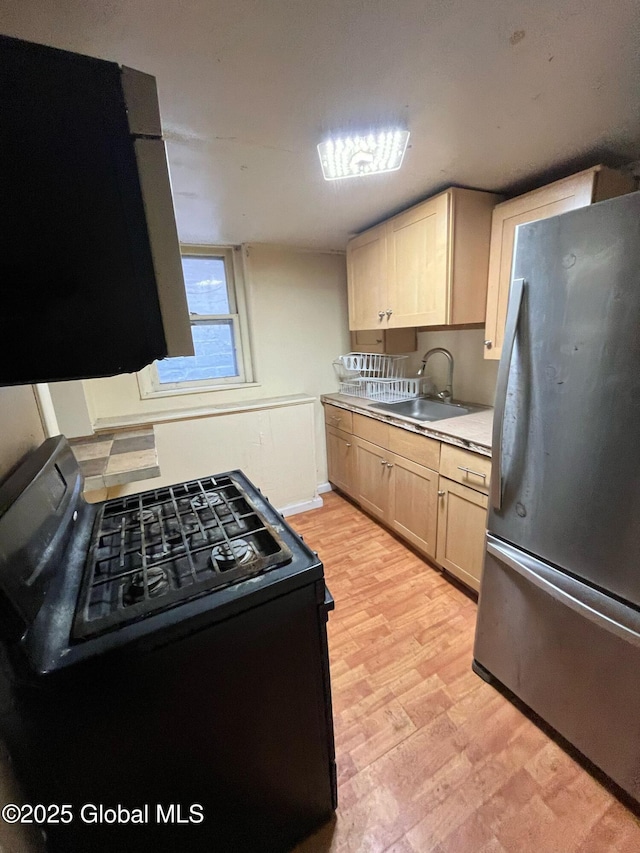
[347,187,500,330]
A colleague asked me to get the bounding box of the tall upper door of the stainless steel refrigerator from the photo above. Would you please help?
[488,193,640,606]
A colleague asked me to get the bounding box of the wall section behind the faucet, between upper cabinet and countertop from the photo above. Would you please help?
[408,329,498,406]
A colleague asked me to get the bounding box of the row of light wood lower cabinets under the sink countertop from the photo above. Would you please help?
[325,407,490,590]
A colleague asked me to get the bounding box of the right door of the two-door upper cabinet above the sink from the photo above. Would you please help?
[387,193,451,327]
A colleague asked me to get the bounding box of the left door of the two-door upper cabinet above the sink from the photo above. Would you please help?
[347,224,388,329]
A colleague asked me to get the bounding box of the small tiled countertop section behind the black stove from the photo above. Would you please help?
[69,427,160,492]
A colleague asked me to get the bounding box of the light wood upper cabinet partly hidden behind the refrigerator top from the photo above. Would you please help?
[484,166,636,359]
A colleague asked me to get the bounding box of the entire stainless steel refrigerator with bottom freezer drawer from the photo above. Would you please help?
[474,188,640,800]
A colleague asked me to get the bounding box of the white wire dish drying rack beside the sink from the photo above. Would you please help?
[333,352,420,403]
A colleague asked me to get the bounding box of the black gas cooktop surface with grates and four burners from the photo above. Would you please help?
[72,472,292,639]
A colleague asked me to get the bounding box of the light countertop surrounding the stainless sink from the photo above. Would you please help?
[320,394,493,456]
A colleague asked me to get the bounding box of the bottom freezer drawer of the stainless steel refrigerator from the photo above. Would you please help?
[474,535,640,799]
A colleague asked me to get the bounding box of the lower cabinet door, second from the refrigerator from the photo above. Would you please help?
[388,454,438,557]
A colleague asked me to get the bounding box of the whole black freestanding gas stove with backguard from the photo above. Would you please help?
[0,437,336,853]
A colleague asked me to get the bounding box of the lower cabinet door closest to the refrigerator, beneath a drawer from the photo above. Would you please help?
[436,477,488,591]
